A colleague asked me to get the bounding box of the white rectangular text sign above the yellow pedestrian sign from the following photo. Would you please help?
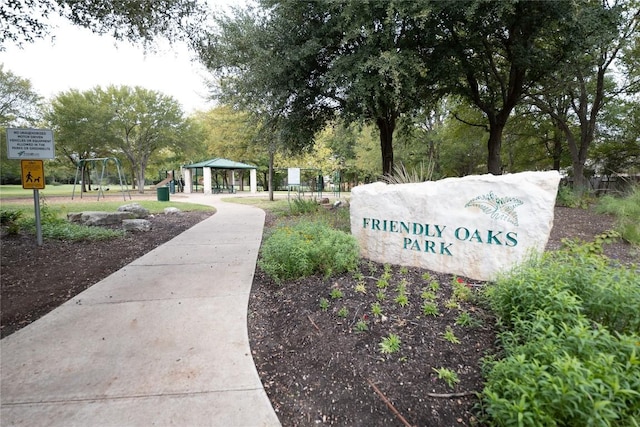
[7,128,56,160]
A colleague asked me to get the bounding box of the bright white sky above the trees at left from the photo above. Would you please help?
[0,0,240,114]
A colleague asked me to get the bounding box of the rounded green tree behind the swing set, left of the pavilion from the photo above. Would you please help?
[47,86,193,192]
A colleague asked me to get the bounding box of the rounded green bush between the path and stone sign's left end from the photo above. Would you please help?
[258,220,359,282]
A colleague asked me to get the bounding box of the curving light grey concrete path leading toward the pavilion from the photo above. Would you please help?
[0,195,280,427]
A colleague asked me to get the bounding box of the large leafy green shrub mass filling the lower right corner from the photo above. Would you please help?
[482,242,640,426]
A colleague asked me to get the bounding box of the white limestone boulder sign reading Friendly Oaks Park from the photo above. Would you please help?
[350,171,560,280]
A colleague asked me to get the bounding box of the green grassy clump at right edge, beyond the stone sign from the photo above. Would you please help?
[596,186,640,245]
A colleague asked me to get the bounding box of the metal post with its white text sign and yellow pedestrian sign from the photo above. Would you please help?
[7,128,55,246]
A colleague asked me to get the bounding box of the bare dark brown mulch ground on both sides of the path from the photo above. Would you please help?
[0,203,640,426]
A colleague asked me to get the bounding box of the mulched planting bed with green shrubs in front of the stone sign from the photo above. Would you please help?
[249,206,640,426]
